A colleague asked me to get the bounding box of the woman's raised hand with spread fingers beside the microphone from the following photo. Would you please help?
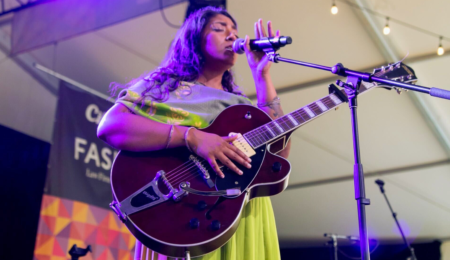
[244,19,280,77]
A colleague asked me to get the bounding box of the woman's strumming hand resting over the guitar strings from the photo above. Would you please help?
[187,128,251,178]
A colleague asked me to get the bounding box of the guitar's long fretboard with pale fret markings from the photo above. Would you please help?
[243,83,375,149]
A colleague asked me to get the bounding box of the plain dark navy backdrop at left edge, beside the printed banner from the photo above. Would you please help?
[0,125,50,260]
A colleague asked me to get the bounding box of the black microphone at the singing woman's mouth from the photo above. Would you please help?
[233,36,292,54]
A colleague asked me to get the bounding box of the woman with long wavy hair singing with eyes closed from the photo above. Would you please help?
[98,7,289,260]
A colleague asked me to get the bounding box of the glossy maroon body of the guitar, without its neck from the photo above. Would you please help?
[111,105,290,257]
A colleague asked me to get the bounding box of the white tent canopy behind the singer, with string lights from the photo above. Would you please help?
[0,0,450,246]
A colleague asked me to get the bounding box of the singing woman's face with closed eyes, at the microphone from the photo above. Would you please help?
[201,14,238,68]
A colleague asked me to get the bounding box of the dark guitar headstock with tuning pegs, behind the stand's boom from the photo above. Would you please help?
[372,61,417,94]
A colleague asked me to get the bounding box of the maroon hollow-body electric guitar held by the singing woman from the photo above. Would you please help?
[110,62,417,257]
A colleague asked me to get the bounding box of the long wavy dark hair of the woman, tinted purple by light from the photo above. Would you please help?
[110,6,242,102]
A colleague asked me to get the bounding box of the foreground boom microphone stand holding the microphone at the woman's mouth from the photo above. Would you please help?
[263,47,450,260]
